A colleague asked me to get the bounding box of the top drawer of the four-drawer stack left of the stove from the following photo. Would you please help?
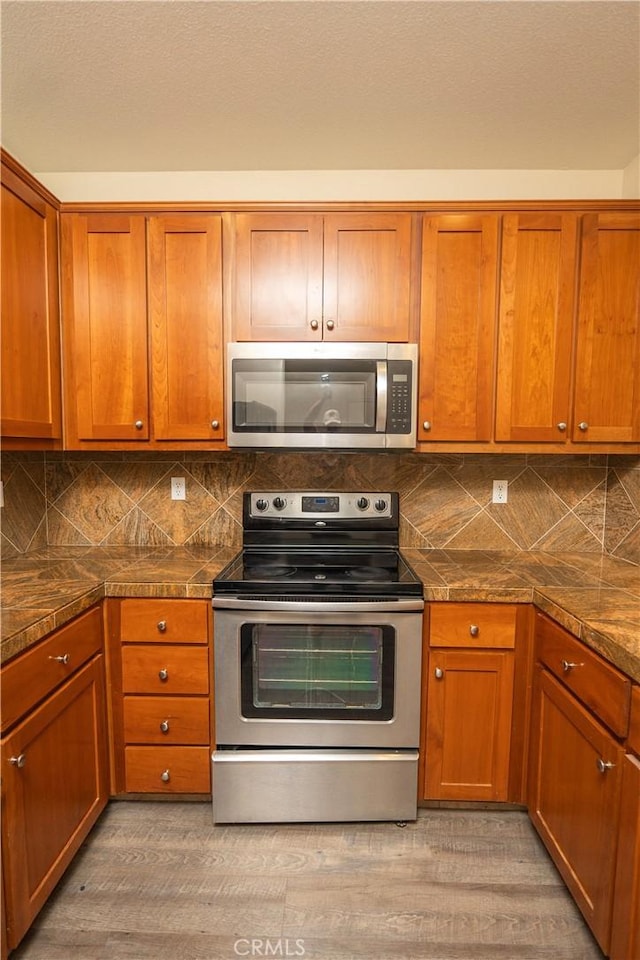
[120,599,209,643]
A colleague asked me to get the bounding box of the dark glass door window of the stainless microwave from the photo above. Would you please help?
[232,359,377,433]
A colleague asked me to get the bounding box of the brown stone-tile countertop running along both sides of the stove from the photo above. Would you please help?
[0,545,640,683]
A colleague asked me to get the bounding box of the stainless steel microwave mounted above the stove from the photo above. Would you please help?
[227,341,418,449]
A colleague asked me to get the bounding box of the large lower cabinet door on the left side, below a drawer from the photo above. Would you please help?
[2,656,107,948]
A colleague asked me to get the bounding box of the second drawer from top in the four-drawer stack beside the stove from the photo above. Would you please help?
[122,644,209,694]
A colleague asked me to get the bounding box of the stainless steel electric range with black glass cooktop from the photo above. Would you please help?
[213,491,424,823]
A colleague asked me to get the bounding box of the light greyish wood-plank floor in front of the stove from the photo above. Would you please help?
[11,802,602,960]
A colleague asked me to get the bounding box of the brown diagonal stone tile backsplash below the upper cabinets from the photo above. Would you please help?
[0,451,640,563]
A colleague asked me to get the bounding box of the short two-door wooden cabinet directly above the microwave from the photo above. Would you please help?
[231,212,413,342]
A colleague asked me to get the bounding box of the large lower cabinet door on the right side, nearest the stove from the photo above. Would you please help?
[529,670,623,953]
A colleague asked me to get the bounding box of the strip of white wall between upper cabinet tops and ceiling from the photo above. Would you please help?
[34,168,624,203]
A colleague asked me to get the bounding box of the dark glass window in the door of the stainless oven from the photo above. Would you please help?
[240,623,396,720]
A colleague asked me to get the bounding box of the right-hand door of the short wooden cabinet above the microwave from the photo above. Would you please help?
[323,213,411,343]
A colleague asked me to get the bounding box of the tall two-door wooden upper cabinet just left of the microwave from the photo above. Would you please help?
[61,213,224,448]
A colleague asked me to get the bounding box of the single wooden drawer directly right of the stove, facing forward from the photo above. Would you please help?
[429,603,516,649]
